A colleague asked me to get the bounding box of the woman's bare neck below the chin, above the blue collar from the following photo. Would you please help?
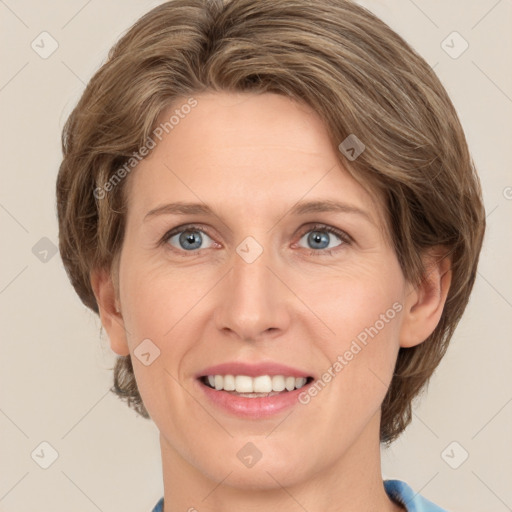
[160,411,405,512]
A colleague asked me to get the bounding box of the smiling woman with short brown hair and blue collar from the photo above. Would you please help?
[57,0,485,512]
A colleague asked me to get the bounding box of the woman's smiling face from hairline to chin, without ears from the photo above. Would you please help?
[113,93,407,488]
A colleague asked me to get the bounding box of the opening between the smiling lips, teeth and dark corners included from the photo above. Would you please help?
[199,375,313,398]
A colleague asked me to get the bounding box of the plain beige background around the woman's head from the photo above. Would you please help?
[0,0,512,512]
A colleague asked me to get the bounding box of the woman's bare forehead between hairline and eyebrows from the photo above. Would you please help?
[127,93,388,230]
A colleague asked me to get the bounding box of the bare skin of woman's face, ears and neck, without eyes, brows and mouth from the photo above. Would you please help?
[91,92,451,512]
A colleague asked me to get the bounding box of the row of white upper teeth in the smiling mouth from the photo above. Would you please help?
[206,375,307,393]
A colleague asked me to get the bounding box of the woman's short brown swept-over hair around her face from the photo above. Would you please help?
[57,0,485,443]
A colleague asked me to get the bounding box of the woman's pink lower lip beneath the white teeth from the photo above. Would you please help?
[197,380,311,419]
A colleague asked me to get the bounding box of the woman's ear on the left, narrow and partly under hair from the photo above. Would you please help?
[91,269,130,356]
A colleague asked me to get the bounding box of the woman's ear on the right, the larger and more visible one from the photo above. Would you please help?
[400,246,452,348]
